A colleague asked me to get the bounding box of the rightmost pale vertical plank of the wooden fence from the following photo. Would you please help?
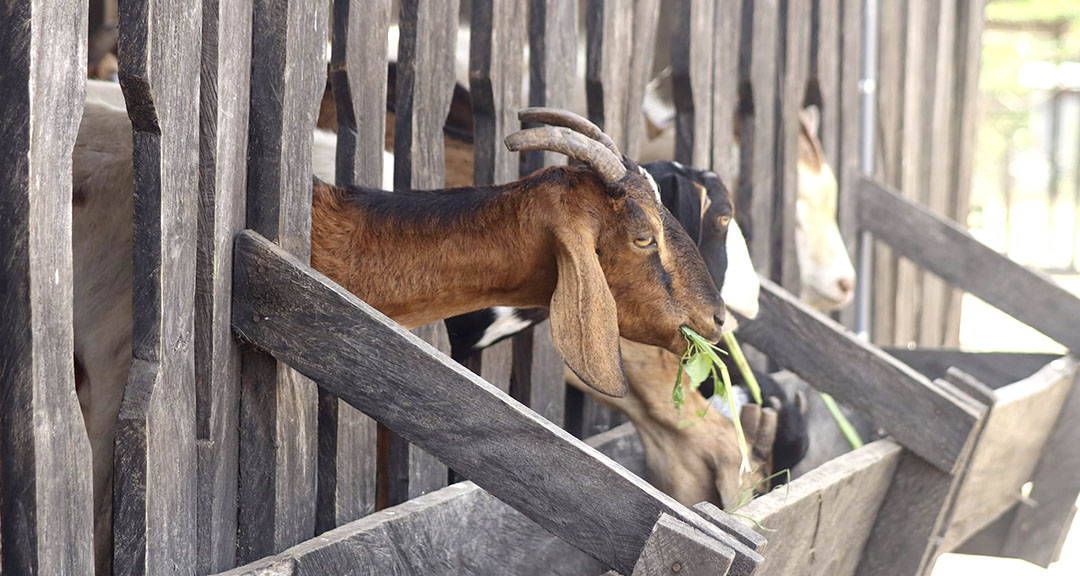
[945,0,986,346]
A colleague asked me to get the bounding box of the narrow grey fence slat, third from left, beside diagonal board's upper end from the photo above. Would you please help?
[194,0,253,574]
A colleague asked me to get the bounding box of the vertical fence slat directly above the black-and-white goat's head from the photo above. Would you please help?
[671,0,716,166]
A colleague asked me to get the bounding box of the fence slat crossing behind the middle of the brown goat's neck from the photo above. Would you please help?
[379,0,458,506]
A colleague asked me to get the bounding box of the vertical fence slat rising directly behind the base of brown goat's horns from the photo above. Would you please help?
[585,0,634,150]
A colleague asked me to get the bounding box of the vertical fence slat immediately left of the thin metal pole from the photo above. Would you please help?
[822,0,859,327]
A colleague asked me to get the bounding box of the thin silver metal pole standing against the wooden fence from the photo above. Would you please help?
[855,0,878,339]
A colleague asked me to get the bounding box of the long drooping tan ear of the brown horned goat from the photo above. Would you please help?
[551,229,626,398]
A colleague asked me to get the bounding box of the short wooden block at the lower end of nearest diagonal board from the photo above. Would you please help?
[633,514,735,576]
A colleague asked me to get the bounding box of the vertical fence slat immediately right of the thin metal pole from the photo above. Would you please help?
[868,0,907,346]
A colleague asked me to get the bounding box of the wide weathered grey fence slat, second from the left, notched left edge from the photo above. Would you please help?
[113,0,202,574]
